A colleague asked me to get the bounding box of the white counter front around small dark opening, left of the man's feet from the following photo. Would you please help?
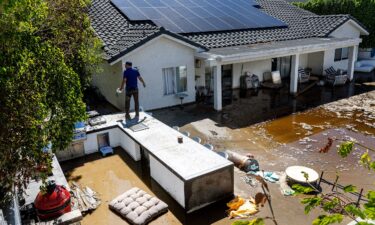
[83,128,120,154]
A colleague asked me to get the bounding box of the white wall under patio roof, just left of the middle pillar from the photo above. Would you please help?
[233,59,271,88]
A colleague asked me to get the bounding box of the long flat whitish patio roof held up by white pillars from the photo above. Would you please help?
[200,38,362,65]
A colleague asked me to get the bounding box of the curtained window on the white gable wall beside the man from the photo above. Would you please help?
[163,66,187,95]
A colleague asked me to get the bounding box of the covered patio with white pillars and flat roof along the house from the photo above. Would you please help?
[195,37,361,111]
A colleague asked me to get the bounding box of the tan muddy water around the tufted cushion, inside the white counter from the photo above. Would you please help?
[61,148,180,225]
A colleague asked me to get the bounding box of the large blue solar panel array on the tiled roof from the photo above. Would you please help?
[111,0,286,33]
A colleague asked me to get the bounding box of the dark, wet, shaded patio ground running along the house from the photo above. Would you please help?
[153,78,375,129]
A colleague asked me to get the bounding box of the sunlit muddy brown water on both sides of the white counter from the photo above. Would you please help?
[62,89,375,225]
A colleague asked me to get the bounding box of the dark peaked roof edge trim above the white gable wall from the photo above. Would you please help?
[107,27,209,64]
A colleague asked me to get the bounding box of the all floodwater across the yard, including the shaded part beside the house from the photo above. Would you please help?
[62,84,375,225]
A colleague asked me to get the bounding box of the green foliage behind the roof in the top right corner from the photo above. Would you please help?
[295,0,375,48]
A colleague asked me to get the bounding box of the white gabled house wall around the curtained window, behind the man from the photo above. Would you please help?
[123,37,195,110]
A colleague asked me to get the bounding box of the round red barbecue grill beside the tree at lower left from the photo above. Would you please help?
[34,181,72,220]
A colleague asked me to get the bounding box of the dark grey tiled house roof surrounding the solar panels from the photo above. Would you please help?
[89,0,370,62]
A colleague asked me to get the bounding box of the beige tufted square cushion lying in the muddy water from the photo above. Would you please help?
[109,187,168,225]
